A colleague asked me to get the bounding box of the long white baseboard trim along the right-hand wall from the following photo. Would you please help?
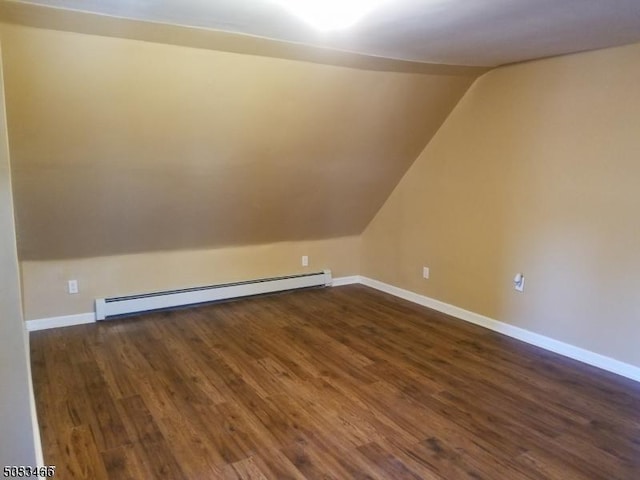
[360,277,640,382]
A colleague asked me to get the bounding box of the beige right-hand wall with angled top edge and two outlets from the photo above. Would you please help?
[362,44,640,366]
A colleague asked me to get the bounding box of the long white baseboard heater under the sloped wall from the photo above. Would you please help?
[96,270,331,320]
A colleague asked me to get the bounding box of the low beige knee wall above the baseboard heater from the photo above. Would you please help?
[21,237,360,320]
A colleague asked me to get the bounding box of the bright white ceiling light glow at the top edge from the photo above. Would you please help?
[273,0,389,30]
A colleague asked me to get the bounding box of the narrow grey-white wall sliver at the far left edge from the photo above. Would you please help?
[0,40,37,467]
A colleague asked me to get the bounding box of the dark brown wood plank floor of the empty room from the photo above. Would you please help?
[31,285,640,480]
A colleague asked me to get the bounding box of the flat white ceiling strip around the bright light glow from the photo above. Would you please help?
[10,0,640,66]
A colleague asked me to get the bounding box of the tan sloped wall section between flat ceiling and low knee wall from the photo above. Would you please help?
[1,24,474,260]
